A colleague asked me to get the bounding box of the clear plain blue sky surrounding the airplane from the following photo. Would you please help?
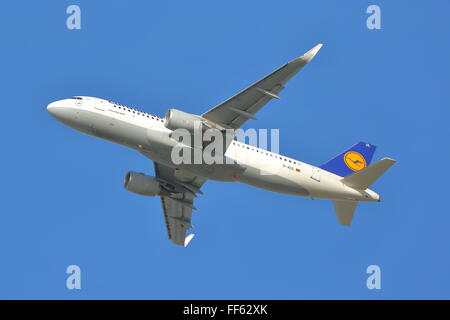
[0,0,450,299]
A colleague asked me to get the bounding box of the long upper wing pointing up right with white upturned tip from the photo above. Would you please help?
[202,44,322,129]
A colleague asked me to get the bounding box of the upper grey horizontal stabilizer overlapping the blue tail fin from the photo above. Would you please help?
[342,158,397,190]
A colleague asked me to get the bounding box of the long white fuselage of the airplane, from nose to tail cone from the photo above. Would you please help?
[47,97,379,201]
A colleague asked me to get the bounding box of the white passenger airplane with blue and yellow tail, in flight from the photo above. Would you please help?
[47,44,396,247]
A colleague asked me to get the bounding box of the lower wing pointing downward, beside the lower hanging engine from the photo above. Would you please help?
[151,162,206,246]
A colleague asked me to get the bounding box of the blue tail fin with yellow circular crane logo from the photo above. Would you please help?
[320,142,376,177]
